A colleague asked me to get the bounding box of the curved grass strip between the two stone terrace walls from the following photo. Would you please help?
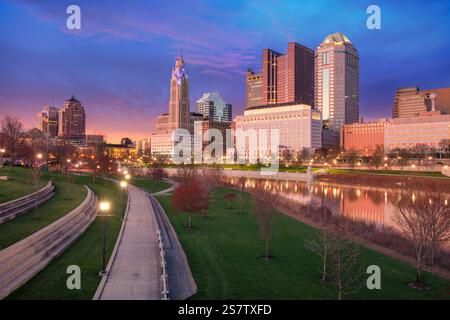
[0,168,86,250]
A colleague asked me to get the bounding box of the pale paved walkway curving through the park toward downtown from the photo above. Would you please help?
[100,185,161,300]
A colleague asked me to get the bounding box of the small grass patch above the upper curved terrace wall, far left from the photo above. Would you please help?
[0,167,48,203]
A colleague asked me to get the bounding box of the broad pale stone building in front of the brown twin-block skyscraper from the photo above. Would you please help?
[235,103,322,159]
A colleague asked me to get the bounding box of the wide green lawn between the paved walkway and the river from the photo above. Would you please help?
[158,188,450,299]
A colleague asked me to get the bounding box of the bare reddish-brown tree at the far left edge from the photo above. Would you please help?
[1,116,24,172]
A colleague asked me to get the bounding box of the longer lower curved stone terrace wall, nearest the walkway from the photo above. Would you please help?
[0,186,98,299]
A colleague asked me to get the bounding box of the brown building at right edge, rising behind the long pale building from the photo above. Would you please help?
[392,87,450,118]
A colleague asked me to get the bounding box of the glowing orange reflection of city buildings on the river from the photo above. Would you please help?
[230,179,446,227]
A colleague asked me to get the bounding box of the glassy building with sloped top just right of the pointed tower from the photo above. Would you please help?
[196,92,232,122]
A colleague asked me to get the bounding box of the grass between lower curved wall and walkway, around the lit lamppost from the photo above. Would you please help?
[8,177,124,300]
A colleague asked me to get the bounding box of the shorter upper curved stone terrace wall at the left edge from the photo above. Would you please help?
[0,181,55,224]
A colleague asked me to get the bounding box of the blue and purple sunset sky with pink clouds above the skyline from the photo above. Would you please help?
[0,0,450,142]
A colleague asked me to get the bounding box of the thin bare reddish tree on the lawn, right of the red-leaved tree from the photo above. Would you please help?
[252,187,277,261]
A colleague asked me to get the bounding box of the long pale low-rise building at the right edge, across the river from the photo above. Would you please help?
[384,111,450,152]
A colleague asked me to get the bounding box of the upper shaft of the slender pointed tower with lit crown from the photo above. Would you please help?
[169,57,189,131]
